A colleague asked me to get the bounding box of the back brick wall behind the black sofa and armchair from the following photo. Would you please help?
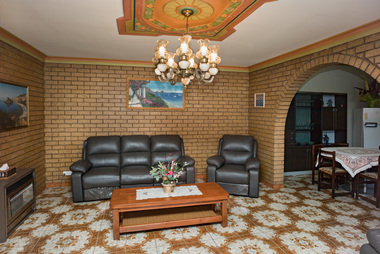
[45,63,249,186]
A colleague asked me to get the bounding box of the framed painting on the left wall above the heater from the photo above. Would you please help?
[0,82,29,131]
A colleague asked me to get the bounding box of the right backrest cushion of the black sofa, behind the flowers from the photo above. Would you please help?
[150,135,185,165]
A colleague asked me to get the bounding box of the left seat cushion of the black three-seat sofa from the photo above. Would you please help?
[83,167,120,189]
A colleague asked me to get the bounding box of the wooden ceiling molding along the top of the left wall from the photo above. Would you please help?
[0,27,46,62]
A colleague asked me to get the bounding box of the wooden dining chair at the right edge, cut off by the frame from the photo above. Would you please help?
[355,156,380,208]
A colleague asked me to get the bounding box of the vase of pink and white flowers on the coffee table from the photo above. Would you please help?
[150,159,186,193]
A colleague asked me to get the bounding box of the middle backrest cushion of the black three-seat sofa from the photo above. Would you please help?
[121,135,151,167]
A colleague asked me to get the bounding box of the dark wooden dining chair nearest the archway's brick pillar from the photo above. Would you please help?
[318,150,354,198]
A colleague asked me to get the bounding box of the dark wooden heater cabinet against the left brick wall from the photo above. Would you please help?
[0,168,36,243]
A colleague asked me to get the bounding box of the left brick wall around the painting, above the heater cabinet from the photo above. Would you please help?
[0,41,45,192]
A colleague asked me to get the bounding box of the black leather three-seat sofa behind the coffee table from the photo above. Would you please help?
[70,135,195,202]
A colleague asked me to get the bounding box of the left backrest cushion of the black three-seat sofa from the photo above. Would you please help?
[83,136,120,168]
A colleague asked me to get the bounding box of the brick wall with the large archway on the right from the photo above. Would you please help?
[249,33,380,187]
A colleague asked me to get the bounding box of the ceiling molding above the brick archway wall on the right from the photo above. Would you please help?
[248,19,380,72]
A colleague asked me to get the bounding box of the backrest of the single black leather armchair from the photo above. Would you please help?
[219,135,257,165]
